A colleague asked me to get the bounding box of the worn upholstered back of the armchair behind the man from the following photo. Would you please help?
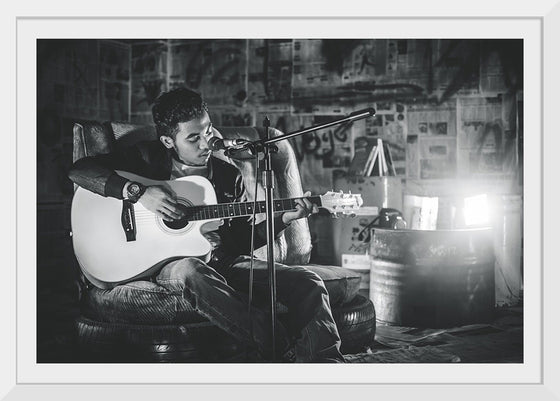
[73,121,311,264]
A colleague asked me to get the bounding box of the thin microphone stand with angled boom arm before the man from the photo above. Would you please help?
[227,108,375,362]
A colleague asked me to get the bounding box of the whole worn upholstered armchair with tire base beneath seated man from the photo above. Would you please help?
[73,121,375,362]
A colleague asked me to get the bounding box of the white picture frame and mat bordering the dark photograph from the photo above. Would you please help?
[5,1,560,400]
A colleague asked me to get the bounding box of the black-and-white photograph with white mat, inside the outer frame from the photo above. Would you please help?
[5,4,552,399]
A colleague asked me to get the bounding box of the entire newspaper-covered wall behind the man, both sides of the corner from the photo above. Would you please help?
[37,39,523,201]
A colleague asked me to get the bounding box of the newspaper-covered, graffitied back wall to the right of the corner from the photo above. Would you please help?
[130,39,523,193]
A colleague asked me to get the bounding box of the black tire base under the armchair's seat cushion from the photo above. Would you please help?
[72,295,376,363]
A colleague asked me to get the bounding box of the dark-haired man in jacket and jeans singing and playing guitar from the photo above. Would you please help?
[69,88,344,362]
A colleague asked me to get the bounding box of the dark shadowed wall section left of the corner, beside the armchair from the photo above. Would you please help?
[37,39,131,300]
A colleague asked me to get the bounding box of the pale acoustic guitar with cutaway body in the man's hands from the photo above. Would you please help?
[71,171,363,288]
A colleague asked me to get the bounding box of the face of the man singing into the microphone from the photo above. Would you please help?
[160,112,212,166]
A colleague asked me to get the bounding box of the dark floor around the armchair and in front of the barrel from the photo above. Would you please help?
[37,274,523,363]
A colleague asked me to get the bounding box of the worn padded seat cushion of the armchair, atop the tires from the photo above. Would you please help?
[82,264,361,324]
